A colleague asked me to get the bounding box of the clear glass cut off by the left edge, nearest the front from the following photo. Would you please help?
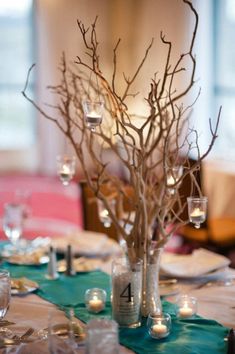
[0,269,11,336]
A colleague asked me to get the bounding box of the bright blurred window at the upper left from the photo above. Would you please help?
[0,0,35,150]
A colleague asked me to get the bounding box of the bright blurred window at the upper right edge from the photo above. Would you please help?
[214,0,235,160]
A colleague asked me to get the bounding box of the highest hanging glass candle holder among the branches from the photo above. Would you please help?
[82,101,104,131]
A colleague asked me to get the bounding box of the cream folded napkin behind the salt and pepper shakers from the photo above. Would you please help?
[51,231,120,256]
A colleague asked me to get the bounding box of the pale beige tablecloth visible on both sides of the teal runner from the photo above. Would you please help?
[0,239,235,354]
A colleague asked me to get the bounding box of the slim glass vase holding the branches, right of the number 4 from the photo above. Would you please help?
[141,248,163,317]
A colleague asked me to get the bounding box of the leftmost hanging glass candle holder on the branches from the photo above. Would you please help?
[56,155,75,186]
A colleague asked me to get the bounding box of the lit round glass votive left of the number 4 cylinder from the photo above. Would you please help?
[85,288,107,313]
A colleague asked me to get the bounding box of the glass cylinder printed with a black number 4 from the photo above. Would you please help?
[112,257,143,328]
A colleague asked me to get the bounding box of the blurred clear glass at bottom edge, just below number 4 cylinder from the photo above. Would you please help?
[86,318,119,354]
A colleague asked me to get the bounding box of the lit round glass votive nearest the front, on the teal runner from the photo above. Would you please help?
[147,313,171,339]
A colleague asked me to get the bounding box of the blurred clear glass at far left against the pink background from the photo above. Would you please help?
[3,203,24,247]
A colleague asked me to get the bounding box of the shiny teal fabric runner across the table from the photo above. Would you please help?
[2,262,228,354]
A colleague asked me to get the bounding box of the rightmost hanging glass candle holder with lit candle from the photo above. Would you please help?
[187,197,207,229]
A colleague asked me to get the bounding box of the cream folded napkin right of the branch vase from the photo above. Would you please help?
[161,248,230,278]
